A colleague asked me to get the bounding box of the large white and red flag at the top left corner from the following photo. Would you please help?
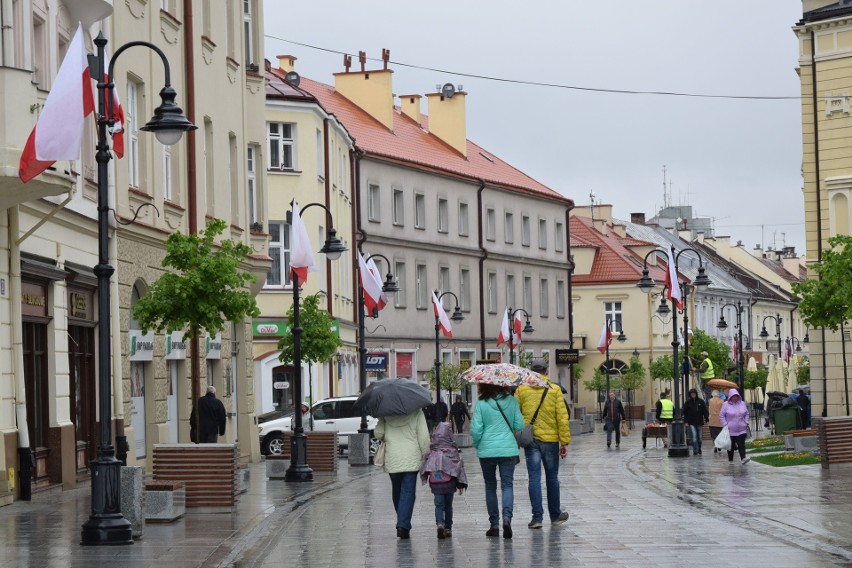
[18,24,95,183]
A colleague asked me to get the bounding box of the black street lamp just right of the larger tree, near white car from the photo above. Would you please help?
[284,200,346,481]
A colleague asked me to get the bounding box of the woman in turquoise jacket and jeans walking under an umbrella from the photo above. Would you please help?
[470,384,524,539]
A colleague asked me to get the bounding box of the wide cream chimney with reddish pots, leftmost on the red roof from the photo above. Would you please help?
[334,51,393,130]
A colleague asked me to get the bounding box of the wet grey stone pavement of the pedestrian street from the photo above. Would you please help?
[0,426,852,568]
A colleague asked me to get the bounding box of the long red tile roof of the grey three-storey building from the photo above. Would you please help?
[271,68,573,204]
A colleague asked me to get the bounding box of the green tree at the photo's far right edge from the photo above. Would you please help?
[792,235,852,416]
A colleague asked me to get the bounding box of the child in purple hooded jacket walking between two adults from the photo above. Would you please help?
[420,423,467,539]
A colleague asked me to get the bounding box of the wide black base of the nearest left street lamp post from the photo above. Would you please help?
[80,456,133,546]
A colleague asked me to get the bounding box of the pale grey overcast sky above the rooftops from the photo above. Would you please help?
[264,0,805,254]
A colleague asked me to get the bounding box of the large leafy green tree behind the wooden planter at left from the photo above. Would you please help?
[133,219,260,444]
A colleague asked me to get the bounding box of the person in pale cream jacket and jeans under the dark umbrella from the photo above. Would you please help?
[373,410,429,539]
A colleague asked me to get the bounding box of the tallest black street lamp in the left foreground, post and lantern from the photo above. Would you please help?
[81,33,196,545]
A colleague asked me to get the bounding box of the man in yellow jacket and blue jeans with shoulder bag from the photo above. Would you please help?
[515,359,571,529]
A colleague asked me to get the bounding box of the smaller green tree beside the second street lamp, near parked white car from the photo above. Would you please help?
[278,294,343,430]
